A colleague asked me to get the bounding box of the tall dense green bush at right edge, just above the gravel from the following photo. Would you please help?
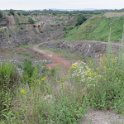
[88,55,124,113]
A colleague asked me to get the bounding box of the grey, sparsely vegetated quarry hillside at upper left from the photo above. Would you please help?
[0,11,74,48]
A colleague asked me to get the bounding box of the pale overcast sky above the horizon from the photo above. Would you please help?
[0,0,124,10]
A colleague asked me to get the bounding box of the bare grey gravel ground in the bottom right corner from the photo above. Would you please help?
[81,110,124,124]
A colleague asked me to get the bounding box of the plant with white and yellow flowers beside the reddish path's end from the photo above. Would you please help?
[70,61,101,86]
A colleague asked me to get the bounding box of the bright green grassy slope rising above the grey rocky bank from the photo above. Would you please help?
[65,16,124,41]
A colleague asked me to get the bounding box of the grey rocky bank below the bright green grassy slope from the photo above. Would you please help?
[42,41,123,58]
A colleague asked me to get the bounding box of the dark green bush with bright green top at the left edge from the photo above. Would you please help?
[0,63,19,119]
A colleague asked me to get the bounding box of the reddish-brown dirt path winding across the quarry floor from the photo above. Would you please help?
[32,43,71,69]
